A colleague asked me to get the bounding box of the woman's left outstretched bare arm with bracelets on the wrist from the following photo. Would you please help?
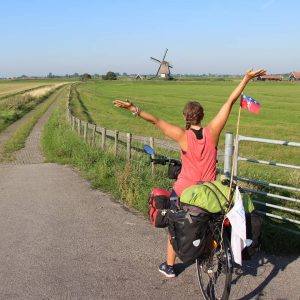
[113,100,185,145]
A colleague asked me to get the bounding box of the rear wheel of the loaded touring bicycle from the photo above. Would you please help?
[196,230,233,300]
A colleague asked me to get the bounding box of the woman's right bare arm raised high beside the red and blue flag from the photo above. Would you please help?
[208,69,266,146]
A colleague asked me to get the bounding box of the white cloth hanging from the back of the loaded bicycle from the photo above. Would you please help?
[227,187,247,265]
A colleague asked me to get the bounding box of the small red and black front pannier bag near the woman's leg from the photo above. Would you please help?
[148,188,171,228]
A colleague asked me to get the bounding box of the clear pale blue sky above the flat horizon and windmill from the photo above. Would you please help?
[0,0,300,77]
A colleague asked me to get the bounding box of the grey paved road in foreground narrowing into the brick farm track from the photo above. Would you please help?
[0,92,300,300]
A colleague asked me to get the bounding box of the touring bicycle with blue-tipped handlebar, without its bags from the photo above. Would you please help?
[144,146,233,300]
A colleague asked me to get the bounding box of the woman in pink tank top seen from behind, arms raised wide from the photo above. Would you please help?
[113,69,266,277]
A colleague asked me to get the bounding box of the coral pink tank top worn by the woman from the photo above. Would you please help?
[173,127,217,196]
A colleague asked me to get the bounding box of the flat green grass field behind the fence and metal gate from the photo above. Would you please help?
[74,80,300,169]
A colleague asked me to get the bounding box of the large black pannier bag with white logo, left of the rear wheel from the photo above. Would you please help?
[168,209,209,262]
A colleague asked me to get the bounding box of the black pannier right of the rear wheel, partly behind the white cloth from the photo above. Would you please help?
[242,211,263,260]
